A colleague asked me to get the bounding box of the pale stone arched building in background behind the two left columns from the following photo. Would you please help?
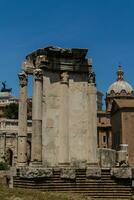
[0,82,32,165]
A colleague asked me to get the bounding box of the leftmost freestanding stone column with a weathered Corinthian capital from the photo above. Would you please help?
[18,72,27,166]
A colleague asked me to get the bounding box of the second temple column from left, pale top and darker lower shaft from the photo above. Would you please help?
[31,69,43,164]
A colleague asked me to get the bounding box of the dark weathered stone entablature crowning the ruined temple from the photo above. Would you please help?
[23,47,91,74]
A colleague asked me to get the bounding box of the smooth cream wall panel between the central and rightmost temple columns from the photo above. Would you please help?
[69,76,90,165]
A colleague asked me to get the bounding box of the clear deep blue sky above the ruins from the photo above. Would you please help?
[0,0,134,99]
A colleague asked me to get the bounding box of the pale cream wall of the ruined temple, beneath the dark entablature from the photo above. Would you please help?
[42,72,92,165]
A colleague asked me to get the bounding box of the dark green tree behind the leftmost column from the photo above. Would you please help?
[4,103,18,119]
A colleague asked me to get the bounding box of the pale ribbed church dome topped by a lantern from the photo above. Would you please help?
[107,66,133,94]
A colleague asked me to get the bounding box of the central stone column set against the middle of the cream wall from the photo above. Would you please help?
[59,72,69,166]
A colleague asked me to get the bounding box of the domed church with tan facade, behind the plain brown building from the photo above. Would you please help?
[97,66,134,148]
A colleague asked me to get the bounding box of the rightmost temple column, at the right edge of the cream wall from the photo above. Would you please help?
[87,72,98,165]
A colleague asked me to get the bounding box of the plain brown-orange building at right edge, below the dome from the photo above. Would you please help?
[111,99,134,166]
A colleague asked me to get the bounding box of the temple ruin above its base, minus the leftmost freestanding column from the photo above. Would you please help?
[23,47,97,167]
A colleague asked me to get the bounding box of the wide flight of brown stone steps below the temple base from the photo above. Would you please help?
[14,170,132,200]
